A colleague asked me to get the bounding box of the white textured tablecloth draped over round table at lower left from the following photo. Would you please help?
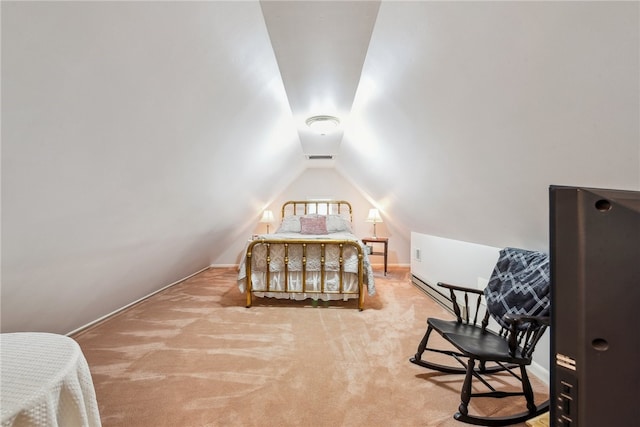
[0,332,101,427]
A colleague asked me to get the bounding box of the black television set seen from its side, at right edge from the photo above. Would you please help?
[549,186,640,427]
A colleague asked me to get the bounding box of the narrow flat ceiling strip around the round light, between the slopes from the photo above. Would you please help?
[260,0,380,160]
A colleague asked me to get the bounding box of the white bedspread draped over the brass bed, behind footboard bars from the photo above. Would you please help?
[238,232,375,299]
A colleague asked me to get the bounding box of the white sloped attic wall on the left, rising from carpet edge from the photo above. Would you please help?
[1,2,301,333]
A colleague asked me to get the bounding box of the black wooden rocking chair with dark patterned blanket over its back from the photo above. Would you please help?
[410,248,551,426]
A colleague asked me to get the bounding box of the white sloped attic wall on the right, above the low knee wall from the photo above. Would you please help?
[337,2,640,251]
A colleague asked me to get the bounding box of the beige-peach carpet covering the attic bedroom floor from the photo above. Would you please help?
[74,268,547,427]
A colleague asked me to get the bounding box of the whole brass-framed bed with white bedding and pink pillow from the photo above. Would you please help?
[238,200,375,310]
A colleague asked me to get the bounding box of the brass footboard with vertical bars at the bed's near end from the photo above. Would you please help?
[244,239,365,310]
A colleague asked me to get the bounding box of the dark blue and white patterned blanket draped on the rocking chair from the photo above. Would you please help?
[484,248,551,327]
